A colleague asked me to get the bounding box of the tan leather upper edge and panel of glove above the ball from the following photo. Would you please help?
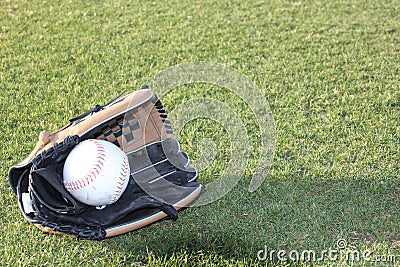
[18,89,172,165]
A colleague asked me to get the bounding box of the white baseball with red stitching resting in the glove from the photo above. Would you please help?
[63,139,130,207]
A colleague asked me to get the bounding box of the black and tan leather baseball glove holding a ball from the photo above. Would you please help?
[9,86,202,239]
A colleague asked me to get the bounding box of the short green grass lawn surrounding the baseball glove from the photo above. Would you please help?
[0,0,400,266]
